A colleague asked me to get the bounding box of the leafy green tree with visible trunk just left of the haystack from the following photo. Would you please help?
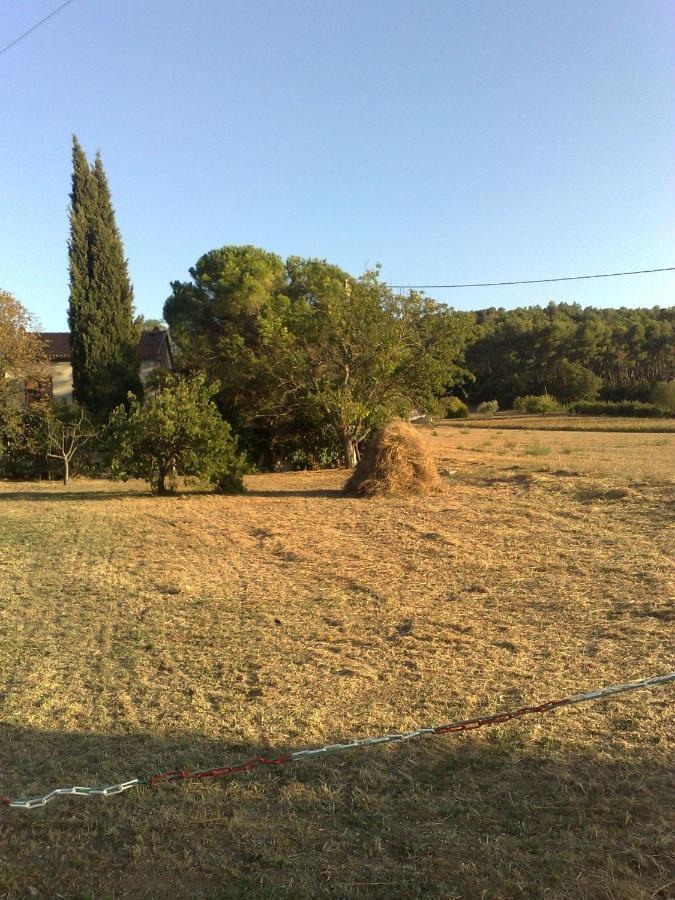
[271,259,476,466]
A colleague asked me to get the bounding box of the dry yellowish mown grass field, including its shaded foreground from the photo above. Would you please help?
[0,425,675,900]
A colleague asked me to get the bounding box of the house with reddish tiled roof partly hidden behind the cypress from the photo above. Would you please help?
[30,328,173,403]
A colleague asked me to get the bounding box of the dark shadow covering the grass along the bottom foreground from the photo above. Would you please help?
[0,719,672,900]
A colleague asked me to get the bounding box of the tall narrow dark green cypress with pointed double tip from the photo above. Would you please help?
[68,136,140,419]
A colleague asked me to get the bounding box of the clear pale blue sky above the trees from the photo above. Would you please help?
[0,0,675,330]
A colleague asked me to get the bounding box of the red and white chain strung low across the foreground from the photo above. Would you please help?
[0,672,675,809]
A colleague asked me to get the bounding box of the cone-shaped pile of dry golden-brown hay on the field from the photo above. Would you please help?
[345,419,442,497]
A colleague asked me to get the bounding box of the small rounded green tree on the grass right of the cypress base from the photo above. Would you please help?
[108,375,246,494]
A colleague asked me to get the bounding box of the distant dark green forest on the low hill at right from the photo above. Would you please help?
[464,302,675,408]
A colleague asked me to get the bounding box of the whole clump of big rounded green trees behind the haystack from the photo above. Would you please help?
[164,247,470,465]
